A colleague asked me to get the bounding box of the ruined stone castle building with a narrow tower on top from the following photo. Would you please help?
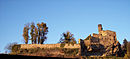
[81,24,121,56]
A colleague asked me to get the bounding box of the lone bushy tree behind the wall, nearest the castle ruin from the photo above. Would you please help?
[59,31,76,44]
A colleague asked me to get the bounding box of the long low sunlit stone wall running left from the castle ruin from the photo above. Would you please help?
[21,44,80,49]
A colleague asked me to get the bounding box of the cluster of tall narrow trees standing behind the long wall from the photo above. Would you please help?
[23,22,48,44]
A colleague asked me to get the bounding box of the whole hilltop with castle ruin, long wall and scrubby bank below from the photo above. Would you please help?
[6,24,129,58]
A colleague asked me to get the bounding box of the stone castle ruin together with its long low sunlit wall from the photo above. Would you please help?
[15,24,121,56]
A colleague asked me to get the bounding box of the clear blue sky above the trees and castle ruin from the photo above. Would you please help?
[0,0,130,53]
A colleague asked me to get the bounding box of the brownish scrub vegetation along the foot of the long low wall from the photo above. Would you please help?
[10,45,79,56]
